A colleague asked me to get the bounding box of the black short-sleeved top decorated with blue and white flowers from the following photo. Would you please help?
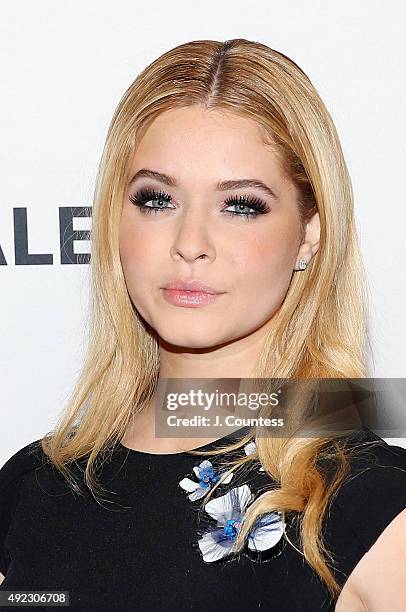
[0,427,406,612]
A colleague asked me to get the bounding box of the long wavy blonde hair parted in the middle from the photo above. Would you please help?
[41,39,376,595]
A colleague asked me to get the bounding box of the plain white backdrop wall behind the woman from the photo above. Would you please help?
[0,0,406,465]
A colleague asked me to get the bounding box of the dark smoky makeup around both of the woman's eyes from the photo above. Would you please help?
[129,188,271,220]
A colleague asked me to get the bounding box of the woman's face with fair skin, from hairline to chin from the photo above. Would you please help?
[120,106,314,349]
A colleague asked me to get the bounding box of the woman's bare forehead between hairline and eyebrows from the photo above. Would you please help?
[131,107,281,189]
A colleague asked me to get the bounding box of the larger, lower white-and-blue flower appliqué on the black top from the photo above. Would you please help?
[198,484,284,563]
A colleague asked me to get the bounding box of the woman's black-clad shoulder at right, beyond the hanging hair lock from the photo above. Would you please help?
[326,428,406,584]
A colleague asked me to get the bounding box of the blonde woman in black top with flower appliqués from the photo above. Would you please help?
[0,39,406,612]
